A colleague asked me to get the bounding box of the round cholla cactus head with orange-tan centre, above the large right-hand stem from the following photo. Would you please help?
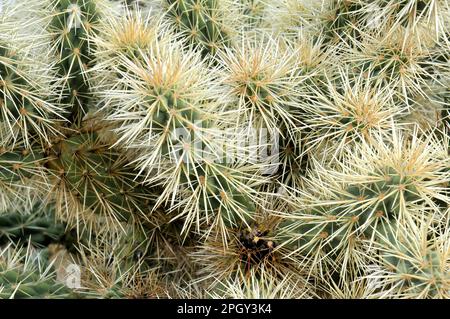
[303,69,407,156]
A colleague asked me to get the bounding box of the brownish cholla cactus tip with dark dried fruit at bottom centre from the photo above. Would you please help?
[192,196,309,294]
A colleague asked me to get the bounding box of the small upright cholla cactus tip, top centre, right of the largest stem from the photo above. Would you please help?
[219,37,303,137]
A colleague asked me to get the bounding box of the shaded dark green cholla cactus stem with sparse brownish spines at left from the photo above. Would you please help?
[47,119,159,227]
